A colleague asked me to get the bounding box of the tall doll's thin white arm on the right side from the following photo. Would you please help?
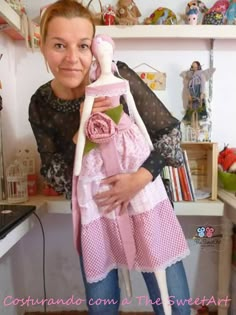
[124,90,153,150]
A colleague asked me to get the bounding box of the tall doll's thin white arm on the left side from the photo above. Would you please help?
[74,96,94,176]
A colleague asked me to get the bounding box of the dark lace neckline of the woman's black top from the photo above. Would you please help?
[40,81,84,113]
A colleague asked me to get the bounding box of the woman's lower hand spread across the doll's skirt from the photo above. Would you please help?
[95,167,152,213]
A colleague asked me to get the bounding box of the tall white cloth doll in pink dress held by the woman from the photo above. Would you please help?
[72,35,189,315]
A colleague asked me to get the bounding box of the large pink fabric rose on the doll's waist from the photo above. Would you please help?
[85,113,117,143]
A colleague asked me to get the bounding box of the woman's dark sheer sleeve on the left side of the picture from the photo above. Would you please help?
[29,96,74,199]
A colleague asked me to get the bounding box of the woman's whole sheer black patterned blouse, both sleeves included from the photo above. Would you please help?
[29,61,183,199]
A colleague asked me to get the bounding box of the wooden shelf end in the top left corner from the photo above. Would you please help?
[0,0,24,40]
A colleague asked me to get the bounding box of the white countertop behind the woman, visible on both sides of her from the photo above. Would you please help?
[0,195,224,258]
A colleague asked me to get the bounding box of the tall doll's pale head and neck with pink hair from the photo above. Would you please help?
[90,35,117,81]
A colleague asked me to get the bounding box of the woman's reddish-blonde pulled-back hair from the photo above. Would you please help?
[40,0,95,44]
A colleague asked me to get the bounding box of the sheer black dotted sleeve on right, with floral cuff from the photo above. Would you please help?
[117,61,183,179]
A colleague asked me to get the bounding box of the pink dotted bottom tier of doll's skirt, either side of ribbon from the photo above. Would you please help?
[81,200,189,282]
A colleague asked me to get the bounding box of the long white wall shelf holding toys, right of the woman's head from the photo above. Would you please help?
[96,25,236,39]
